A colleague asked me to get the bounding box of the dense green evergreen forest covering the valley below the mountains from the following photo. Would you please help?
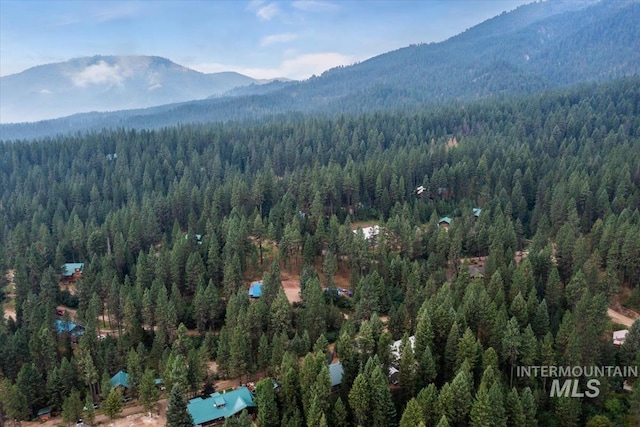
[0,78,640,427]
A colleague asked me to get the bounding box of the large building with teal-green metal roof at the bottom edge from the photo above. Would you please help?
[187,387,256,426]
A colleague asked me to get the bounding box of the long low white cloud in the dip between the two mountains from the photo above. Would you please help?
[190,52,356,80]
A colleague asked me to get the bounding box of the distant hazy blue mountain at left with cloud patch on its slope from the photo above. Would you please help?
[0,56,261,123]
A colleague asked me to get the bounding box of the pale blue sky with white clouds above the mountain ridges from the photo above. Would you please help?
[0,0,531,80]
